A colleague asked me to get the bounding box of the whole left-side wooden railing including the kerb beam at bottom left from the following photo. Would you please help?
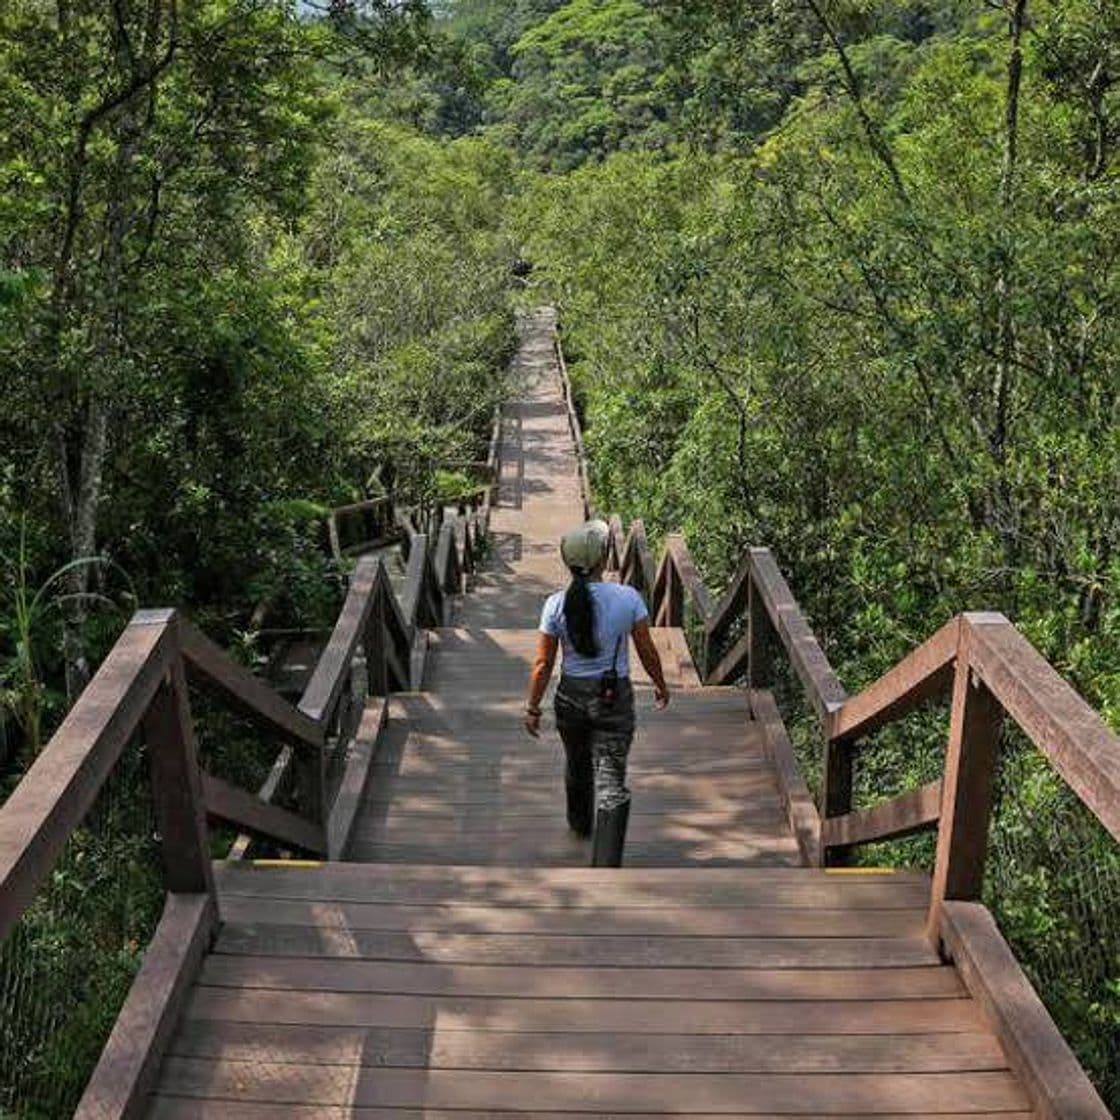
[0,410,501,1117]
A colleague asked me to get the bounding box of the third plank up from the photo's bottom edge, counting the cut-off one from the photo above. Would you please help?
[171,1020,1007,1074]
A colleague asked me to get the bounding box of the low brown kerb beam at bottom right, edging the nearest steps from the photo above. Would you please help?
[940,900,1110,1120]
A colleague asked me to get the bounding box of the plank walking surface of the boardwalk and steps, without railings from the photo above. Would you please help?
[150,316,1032,1120]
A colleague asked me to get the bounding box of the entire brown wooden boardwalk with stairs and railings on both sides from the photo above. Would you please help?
[0,312,1120,1120]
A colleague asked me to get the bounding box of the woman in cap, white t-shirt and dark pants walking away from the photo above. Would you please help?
[524,521,669,867]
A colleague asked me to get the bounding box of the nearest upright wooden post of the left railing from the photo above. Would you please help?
[141,612,214,895]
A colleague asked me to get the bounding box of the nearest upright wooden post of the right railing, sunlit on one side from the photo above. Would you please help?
[928,616,1004,941]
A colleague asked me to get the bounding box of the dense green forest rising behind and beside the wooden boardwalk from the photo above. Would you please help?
[0,0,1120,1107]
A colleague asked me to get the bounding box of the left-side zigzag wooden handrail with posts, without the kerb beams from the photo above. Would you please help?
[0,468,499,940]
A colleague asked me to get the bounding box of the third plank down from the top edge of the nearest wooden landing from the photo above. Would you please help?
[214,923,940,969]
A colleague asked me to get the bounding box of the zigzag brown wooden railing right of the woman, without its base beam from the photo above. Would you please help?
[609,517,1120,882]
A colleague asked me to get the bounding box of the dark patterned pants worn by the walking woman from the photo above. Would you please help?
[554,676,634,810]
